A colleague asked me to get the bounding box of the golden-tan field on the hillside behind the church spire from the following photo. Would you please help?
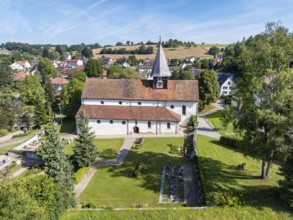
[93,44,226,59]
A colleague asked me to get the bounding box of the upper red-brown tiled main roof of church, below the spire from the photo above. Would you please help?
[81,78,199,102]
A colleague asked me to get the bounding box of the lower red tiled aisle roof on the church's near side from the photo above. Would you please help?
[75,105,181,122]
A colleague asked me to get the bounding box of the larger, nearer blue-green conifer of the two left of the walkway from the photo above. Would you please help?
[37,125,74,192]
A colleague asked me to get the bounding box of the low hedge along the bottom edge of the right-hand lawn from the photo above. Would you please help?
[206,187,280,206]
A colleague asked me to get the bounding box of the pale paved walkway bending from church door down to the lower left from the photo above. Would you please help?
[74,137,135,198]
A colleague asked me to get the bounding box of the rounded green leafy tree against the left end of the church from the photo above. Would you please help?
[61,79,84,117]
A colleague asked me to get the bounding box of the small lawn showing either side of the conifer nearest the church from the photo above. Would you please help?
[65,138,124,159]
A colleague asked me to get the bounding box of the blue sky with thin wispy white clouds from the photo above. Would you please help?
[0,0,293,45]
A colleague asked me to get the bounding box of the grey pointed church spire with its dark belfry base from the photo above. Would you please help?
[151,37,171,89]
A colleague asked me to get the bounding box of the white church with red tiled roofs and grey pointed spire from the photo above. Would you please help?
[75,41,199,135]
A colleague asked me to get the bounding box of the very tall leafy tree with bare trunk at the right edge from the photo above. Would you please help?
[235,23,293,179]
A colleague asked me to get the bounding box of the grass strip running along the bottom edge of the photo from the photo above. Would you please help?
[60,201,293,220]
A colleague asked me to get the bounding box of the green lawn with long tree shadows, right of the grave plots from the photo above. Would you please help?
[197,135,281,192]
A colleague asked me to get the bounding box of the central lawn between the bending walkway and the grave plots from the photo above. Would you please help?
[79,138,185,207]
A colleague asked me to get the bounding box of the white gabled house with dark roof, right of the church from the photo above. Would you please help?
[217,73,235,96]
